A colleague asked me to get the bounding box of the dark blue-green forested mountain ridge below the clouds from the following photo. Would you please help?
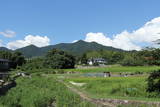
[7,40,123,57]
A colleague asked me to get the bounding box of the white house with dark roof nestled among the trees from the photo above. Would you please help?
[87,58,107,65]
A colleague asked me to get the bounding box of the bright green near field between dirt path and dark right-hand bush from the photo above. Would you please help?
[66,77,160,101]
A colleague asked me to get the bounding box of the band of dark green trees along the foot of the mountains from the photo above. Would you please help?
[0,48,160,69]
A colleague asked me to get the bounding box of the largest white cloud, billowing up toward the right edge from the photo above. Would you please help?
[85,17,160,50]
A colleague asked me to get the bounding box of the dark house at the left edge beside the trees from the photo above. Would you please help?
[0,59,10,72]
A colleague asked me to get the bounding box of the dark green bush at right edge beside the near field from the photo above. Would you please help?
[147,70,160,97]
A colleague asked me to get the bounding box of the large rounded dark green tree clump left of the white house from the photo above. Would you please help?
[44,49,75,69]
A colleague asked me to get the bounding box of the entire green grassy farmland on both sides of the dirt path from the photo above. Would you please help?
[0,66,160,107]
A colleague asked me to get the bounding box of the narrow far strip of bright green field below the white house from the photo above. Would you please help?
[65,66,160,73]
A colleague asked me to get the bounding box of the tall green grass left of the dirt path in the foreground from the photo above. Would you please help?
[0,75,94,107]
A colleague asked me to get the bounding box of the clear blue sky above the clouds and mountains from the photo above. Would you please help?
[0,0,160,48]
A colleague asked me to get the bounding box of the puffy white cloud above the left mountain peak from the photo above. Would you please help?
[7,35,50,50]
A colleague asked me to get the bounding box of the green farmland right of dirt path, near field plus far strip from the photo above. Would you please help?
[62,66,160,107]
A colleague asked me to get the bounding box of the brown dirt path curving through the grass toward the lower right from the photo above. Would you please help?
[60,81,160,107]
